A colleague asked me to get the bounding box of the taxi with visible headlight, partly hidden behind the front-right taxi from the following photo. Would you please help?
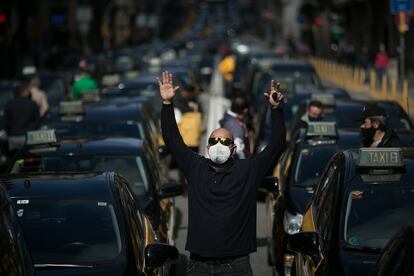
[266,121,361,275]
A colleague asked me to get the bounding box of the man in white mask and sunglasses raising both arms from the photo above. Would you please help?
[158,72,286,276]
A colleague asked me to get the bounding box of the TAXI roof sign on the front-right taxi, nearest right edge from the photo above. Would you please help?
[358,148,404,168]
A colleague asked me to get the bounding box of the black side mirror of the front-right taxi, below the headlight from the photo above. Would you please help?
[288,232,319,264]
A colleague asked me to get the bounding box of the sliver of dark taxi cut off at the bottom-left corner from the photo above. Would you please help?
[0,184,35,276]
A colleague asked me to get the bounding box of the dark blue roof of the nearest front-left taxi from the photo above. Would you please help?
[0,172,113,199]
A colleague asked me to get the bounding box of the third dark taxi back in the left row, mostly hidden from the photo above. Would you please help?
[40,101,159,155]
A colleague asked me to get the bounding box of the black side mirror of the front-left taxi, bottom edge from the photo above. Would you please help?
[145,243,178,275]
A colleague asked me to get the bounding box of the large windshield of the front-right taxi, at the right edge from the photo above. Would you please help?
[344,183,414,249]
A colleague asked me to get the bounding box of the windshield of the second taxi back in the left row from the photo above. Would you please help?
[12,155,149,197]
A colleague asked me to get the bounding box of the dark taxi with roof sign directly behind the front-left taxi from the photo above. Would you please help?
[9,130,183,244]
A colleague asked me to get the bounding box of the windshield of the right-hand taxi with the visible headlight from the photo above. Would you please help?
[293,147,337,187]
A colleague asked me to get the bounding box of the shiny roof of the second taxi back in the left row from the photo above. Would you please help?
[19,138,146,156]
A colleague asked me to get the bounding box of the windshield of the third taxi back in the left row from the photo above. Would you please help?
[42,121,145,139]
